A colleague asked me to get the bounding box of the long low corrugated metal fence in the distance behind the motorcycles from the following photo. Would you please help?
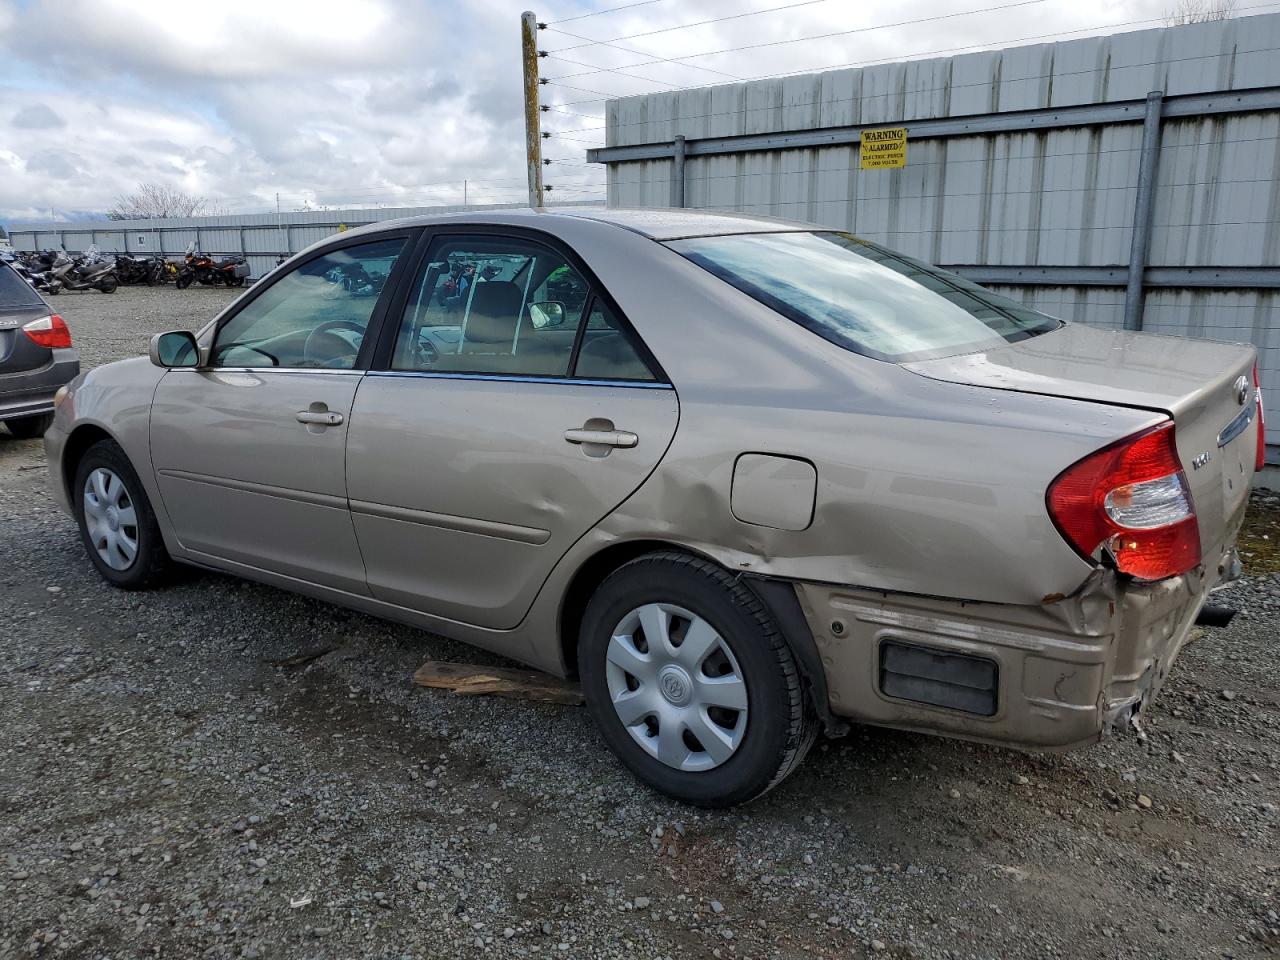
[9,202,596,289]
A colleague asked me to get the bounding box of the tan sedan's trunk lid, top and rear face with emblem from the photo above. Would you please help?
[904,324,1257,564]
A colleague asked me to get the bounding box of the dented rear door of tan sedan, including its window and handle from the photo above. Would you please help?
[347,232,678,628]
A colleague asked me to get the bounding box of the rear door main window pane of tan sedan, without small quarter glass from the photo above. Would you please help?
[392,237,590,376]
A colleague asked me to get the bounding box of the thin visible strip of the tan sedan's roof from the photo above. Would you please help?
[345,207,823,241]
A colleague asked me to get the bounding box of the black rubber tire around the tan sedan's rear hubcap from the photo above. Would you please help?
[579,552,818,808]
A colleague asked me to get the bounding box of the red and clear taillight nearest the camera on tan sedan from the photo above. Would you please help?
[1046,421,1201,580]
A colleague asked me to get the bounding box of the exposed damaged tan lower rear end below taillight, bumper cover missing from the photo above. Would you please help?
[796,550,1234,749]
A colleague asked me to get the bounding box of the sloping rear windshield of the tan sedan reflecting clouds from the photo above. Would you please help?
[668,232,1061,362]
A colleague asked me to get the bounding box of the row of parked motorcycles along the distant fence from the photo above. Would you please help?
[6,243,251,296]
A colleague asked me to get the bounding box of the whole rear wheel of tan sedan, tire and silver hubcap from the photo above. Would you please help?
[579,553,818,806]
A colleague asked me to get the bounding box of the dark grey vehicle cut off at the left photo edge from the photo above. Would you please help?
[0,262,79,439]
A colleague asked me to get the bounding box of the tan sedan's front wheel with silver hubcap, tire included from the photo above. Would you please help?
[72,440,173,590]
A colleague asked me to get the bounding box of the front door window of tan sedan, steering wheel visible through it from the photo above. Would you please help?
[210,238,404,370]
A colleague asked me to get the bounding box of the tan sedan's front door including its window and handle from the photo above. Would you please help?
[151,237,406,594]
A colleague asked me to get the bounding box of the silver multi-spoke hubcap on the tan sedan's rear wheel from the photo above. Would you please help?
[605,603,746,771]
